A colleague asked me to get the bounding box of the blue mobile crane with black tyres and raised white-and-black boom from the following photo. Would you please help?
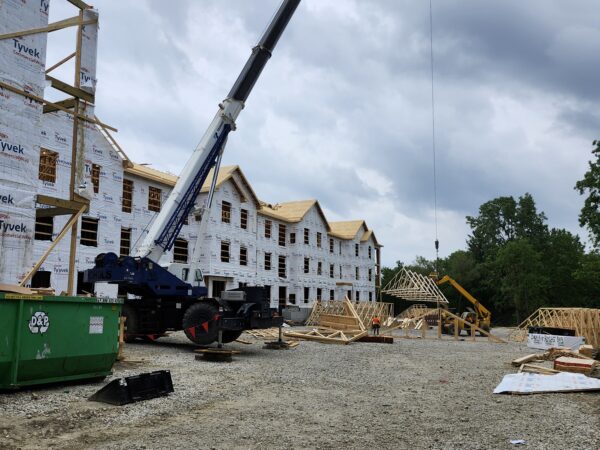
[84,0,300,345]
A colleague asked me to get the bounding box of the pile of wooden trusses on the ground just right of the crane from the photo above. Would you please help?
[284,298,369,345]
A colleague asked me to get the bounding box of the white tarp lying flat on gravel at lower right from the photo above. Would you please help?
[494,372,600,394]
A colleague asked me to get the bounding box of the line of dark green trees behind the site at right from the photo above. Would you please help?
[382,141,600,325]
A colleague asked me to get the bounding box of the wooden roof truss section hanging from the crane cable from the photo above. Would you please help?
[381,268,448,304]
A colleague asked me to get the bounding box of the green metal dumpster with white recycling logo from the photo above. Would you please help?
[0,293,122,389]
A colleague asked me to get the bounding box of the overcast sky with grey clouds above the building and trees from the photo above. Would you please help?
[48,0,600,266]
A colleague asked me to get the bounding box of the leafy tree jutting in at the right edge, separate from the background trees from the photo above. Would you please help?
[575,140,600,248]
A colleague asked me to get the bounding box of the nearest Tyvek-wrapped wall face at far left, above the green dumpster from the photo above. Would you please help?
[0,0,49,283]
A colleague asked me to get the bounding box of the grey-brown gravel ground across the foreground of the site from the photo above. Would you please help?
[0,329,600,449]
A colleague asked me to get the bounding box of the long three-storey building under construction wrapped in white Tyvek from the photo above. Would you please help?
[0,1,381,315]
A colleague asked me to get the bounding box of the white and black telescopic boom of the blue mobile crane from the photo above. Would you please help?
[136,0,300,262]
